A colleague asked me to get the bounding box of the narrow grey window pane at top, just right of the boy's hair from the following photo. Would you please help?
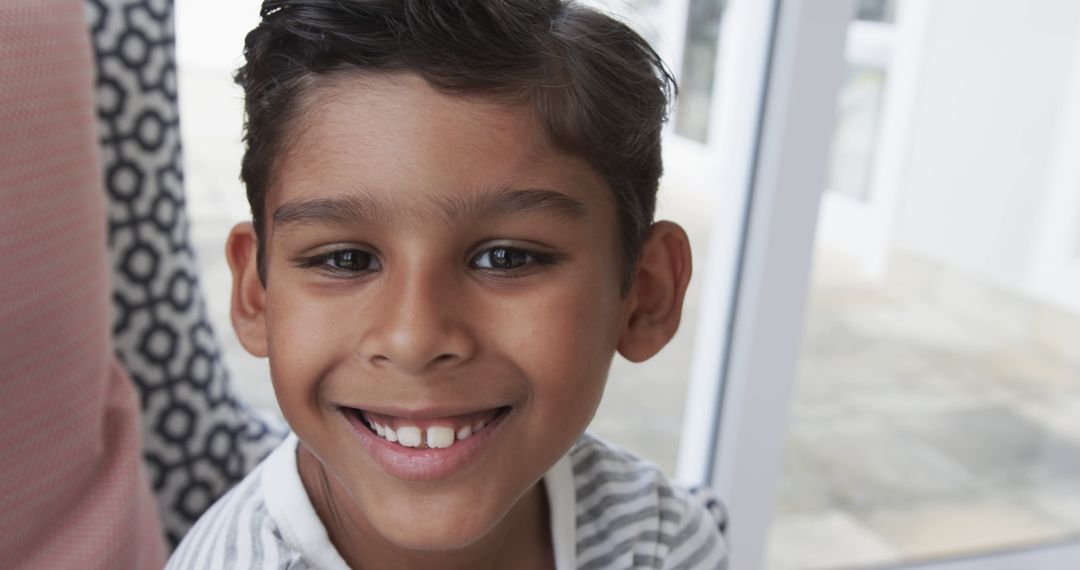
[675,0,727,143]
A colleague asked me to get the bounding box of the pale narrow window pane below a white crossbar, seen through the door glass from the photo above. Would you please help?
[826,67,885,200]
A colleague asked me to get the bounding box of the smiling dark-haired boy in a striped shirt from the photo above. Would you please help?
[171,0,725,569]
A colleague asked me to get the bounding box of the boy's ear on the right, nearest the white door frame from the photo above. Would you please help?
[618,221,691,362]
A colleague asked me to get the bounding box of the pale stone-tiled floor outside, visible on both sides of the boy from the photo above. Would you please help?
[180,69,1080,570]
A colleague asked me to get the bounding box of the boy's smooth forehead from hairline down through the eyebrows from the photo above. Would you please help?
[266,73,615,222]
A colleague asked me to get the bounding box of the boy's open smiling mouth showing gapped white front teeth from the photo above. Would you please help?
[341,406,511,449]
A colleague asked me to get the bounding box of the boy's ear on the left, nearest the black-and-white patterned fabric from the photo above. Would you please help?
[225,221,269,356]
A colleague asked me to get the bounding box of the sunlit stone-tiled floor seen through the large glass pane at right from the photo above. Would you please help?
[769,253,1080,569]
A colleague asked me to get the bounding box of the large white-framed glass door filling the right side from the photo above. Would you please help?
[699,0,1080,570]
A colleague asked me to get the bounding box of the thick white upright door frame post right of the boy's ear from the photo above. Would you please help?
[680,0,854,568]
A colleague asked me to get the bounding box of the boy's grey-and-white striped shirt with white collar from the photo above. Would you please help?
[167,434,727,570]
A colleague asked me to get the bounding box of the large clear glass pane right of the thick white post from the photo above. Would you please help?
[768,0,1080,570]
